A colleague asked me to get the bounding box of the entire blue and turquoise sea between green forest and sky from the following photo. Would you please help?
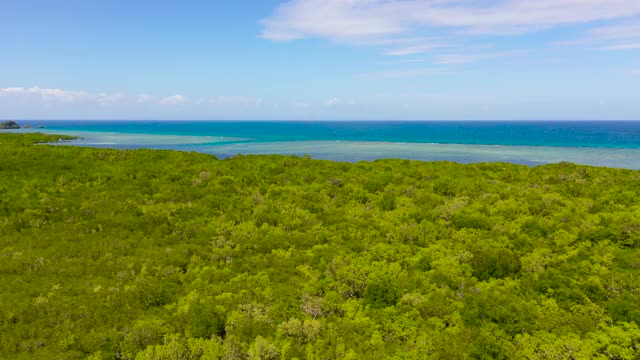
[7,121,640,169]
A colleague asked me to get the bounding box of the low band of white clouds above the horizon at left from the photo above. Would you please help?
[0,86,278,119]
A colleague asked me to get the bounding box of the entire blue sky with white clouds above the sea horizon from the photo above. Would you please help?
[0,0,640,120]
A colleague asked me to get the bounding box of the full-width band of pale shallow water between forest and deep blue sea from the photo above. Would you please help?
[7,129,640,170]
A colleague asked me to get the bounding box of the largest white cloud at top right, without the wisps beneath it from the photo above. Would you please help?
[261,0,640,41]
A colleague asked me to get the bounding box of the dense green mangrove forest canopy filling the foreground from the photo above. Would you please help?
[0,134,640,360]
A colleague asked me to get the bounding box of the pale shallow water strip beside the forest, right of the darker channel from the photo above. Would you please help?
[194,141,640,169]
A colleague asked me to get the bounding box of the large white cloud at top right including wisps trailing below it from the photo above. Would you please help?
[261,0,640,59]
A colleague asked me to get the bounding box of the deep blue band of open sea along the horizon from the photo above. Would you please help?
[17,121,640,148]
